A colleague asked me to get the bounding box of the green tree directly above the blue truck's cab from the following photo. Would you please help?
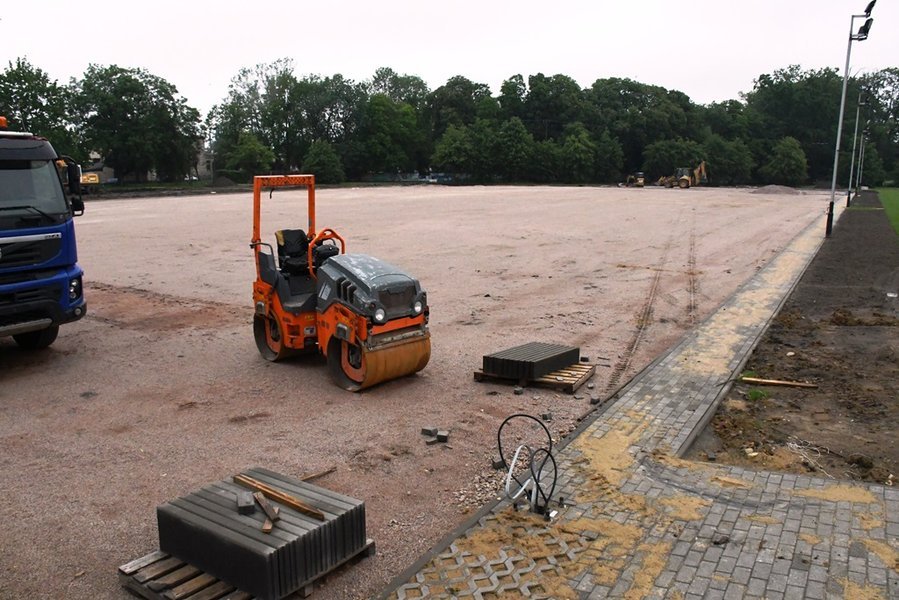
[0,58,81,160]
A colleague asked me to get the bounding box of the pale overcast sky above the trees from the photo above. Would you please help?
[0,0,899,113]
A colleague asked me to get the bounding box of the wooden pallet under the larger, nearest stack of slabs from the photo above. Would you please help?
[119,540,375,600]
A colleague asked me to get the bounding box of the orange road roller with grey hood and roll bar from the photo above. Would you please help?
[250,175,431,392]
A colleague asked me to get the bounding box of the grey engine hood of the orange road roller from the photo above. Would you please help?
[318,254,428,322]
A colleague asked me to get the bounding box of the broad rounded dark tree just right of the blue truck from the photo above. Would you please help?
[73,65,202,181]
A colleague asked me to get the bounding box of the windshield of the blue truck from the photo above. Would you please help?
[0,160,69,216]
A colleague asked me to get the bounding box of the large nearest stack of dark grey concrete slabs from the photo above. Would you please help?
[156,468,367,600]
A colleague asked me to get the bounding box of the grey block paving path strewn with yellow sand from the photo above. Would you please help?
[382,207,899,600]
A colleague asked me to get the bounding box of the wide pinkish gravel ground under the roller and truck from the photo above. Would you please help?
[0,186,828,600]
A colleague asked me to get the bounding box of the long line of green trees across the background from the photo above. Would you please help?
[0,58,899,185]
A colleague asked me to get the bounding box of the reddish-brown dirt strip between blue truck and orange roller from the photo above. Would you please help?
[85,281,252,332]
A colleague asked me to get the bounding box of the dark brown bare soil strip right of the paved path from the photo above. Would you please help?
[691,192,899,485]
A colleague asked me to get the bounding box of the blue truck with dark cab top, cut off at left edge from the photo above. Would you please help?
[0,117,87,350]
